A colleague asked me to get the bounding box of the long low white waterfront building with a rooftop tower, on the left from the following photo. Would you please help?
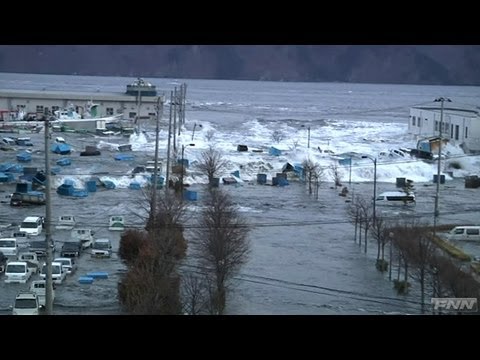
[0,79,163,121]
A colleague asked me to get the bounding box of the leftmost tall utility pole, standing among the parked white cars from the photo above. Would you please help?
[44,118,53,315]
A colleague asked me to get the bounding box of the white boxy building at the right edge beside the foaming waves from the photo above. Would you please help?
[408,102,480,153]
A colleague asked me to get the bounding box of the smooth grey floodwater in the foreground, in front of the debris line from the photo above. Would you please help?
[0,134,480,314]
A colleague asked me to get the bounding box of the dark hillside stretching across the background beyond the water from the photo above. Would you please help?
[0,45,480,85]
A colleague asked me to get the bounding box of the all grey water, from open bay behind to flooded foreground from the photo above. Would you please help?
[0,74,480,315]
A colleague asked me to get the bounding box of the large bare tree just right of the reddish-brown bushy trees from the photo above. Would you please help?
[195,189,250,314]
